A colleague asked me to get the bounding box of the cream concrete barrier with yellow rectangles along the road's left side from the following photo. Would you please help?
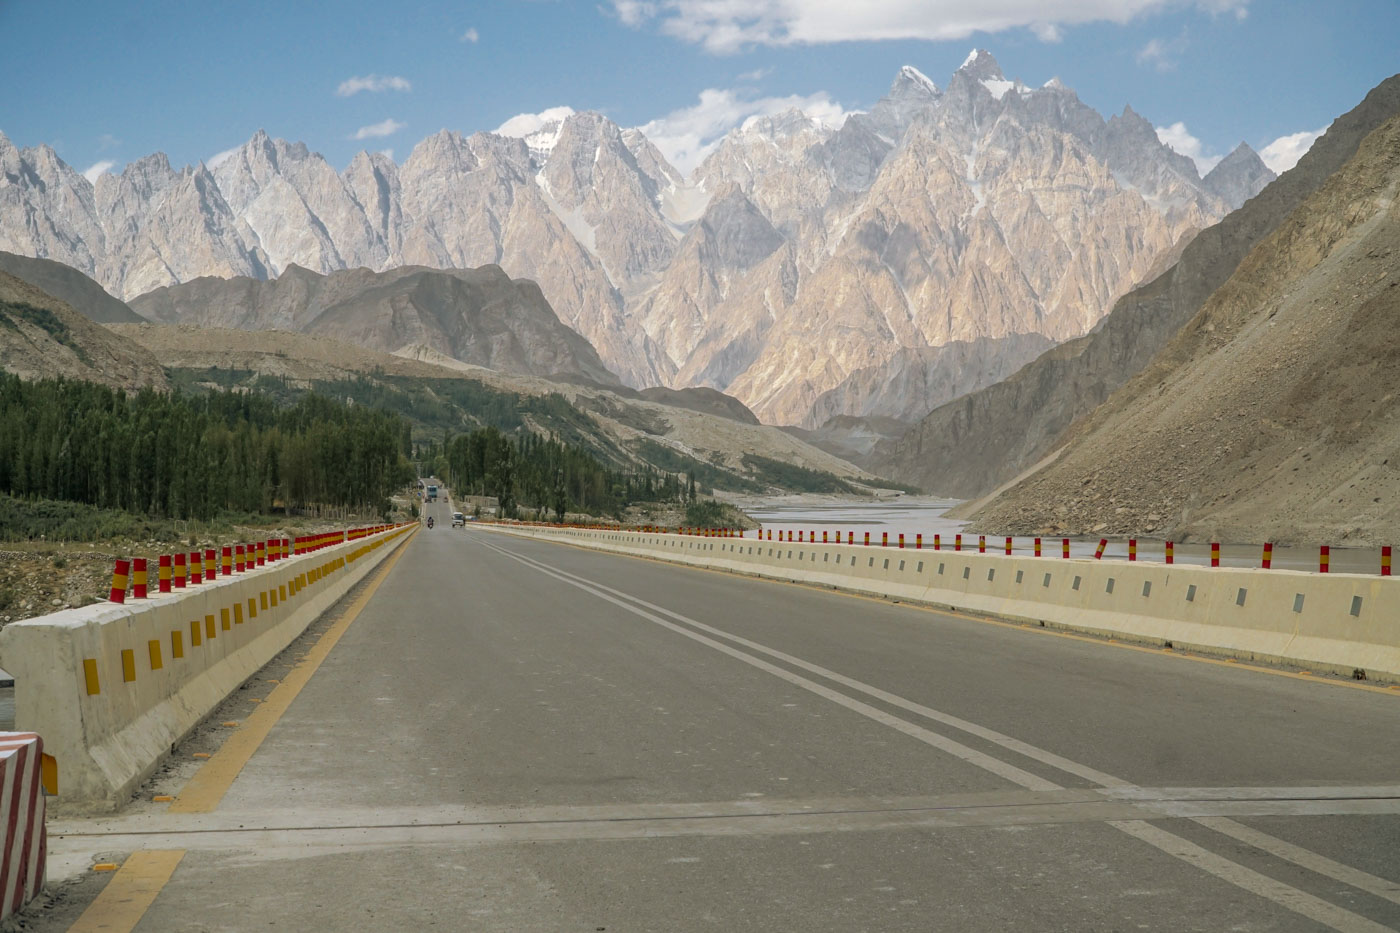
[0,524,417,811]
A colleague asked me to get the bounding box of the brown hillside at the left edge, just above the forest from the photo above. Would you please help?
[0,270,167,389]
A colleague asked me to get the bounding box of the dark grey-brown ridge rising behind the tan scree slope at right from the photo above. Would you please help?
[869,76,1400,499]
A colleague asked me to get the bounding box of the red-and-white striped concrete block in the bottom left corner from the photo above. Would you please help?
[0,733,49,920]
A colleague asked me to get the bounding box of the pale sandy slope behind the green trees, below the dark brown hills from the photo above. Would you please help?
[111,324,875,485]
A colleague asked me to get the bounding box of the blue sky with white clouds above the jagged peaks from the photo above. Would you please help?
[0,0,1400,177]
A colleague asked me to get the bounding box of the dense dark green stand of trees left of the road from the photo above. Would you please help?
[0,374,414,520]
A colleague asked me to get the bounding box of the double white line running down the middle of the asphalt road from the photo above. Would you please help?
[477,538,1400,933]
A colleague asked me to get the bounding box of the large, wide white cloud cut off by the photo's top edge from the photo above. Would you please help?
[612,0,1250,55]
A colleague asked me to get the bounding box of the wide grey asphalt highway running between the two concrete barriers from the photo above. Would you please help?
[38,503,1400,933]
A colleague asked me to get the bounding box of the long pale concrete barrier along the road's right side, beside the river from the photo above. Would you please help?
[493,525,1400,682]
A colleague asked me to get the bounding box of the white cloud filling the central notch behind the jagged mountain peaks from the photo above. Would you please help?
[638,88,846,175]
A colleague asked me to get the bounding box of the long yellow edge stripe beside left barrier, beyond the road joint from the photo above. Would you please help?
[167,526,413,813]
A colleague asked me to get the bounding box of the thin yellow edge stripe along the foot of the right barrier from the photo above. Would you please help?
[497,532,1400,696]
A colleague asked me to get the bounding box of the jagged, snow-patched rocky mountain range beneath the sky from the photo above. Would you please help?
[0,52,1270,427]
